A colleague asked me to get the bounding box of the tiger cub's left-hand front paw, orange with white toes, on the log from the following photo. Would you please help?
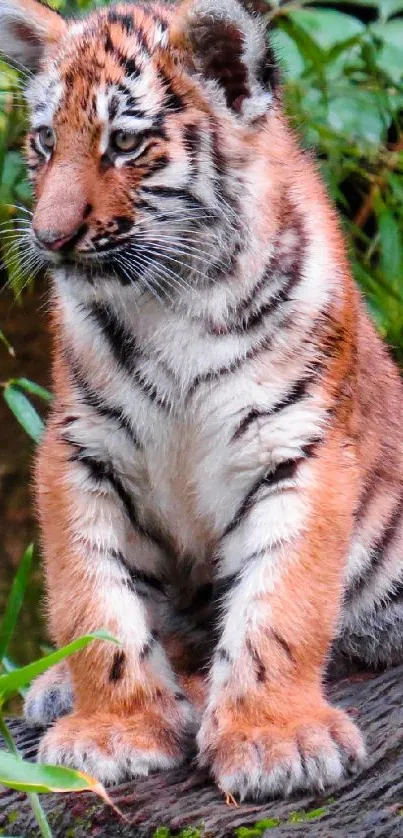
[38,711,195,784]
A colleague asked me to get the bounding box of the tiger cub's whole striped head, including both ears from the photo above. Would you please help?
[0,0,273,296]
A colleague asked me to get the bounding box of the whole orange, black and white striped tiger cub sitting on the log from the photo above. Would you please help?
[0,0,403,799]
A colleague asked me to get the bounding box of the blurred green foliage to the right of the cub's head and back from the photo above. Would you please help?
[268,0,403,362]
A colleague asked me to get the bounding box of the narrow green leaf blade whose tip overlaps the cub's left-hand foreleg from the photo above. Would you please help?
[0,630,119,707]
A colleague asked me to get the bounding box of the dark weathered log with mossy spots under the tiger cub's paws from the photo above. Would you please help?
[0,666,403,838]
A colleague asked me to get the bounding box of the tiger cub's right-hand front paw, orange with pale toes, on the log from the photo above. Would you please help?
[198,705,365,800]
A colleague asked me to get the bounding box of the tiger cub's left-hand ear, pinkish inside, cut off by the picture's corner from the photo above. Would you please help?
[0,0,66,72]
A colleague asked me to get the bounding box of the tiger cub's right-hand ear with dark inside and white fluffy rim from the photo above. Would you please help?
[171,0,278,122]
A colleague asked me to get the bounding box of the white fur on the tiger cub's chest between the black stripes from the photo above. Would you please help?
[56,274,324,561]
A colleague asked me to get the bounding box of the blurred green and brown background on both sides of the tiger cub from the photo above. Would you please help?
[0,0,403,663]
